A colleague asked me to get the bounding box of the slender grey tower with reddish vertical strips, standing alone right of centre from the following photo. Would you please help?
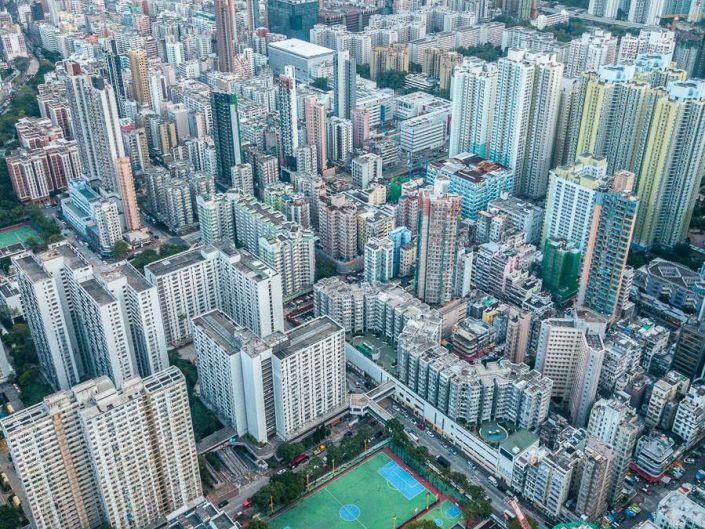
[416,176,462,305]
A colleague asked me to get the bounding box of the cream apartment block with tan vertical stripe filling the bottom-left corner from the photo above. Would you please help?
[0,367,202,529]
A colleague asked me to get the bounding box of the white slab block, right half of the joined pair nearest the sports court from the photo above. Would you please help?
[272,316,348,440]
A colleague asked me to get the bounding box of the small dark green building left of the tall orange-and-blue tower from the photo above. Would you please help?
[542,239,581,303]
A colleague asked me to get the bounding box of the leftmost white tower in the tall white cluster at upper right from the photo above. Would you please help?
[448,58,498,157]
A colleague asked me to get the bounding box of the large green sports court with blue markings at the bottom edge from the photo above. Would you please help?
[269,452,436,529]
